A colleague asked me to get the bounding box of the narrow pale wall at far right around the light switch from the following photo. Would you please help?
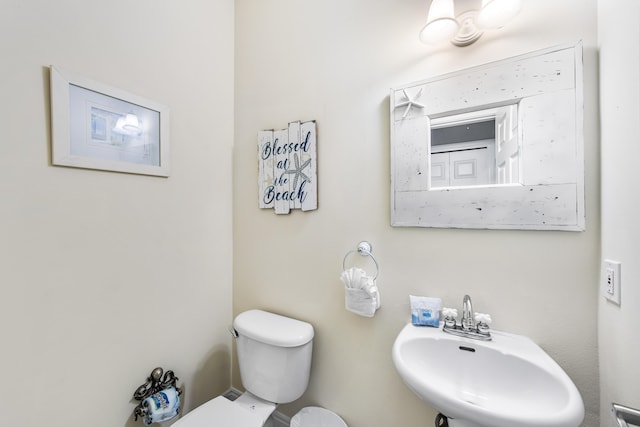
[598,0,640,427]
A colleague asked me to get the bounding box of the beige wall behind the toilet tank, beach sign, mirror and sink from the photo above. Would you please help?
[233,0,600,427]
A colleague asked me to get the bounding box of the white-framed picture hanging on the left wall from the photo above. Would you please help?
[51,66,169,177]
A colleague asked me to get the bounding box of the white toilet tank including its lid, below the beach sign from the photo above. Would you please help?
[233,310,313,403]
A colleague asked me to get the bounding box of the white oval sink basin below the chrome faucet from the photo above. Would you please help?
[393,324,584,427]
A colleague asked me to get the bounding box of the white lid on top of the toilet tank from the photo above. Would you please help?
[233,310,313,347]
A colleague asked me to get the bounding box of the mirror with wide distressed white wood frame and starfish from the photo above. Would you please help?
[390,43,585,231]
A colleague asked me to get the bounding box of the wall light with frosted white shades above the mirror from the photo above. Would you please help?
[420,0,522,47]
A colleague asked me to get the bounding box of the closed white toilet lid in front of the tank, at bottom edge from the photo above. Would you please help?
[173,396,264,427]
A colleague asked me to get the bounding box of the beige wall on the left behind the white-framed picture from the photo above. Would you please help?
[0,0,234,427]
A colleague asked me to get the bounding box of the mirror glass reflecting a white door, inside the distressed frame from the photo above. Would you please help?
[429,104,522,189]
